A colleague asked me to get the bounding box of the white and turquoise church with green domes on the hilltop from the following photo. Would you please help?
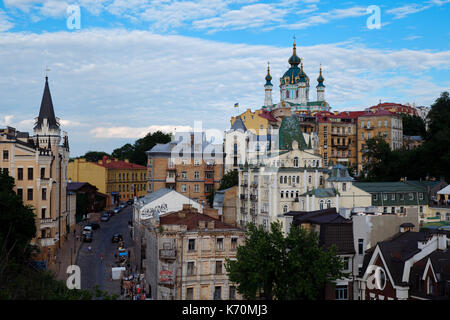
[263,42,331,113]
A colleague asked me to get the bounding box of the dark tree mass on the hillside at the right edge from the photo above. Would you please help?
[358,92,450,181]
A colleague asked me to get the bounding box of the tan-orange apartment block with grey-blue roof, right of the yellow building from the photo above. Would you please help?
[147,132,223,204]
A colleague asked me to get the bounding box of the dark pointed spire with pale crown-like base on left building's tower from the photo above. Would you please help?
[33,75,61,149]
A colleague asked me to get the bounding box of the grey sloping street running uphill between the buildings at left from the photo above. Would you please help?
[76,206,133,295]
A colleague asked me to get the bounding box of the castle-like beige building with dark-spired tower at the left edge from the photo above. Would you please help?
[0,77,70,263]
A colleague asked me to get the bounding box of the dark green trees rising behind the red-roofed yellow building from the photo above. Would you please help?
[111,131,172,166]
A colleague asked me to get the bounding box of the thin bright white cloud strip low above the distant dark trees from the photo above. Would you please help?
[90,125,192,139]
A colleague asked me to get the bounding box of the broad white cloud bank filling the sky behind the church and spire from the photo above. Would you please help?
[0,29,450,154]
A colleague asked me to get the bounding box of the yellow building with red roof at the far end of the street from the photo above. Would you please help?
[67,156,147,206]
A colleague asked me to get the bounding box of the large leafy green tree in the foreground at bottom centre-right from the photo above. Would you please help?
[225,222,344,300]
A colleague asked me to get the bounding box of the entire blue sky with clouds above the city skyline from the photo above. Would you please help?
[0,0,450,156]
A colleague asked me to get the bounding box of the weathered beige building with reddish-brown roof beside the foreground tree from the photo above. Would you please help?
[137,204,245,300]
